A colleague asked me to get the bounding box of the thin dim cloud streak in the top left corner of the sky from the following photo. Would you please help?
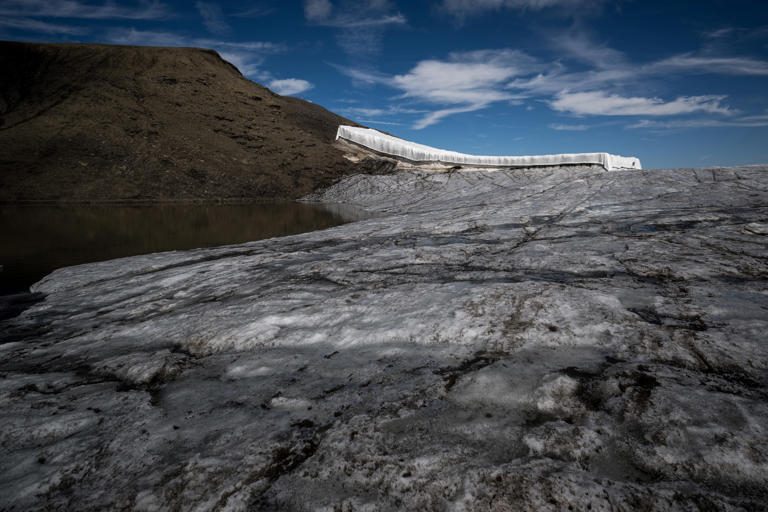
[0,0,168,20]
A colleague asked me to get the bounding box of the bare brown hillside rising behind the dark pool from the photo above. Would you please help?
[0,42,362,201]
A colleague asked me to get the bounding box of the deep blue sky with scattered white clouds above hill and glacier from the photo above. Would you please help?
[0,0,768,168]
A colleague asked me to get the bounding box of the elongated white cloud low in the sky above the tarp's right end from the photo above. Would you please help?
[550,91,734,116]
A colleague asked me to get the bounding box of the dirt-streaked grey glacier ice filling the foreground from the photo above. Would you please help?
[0,166,768,512]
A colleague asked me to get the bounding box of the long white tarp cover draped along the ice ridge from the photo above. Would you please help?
[336,125,642,171]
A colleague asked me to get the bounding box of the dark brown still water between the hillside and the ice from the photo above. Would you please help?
[0,203,354,294]
